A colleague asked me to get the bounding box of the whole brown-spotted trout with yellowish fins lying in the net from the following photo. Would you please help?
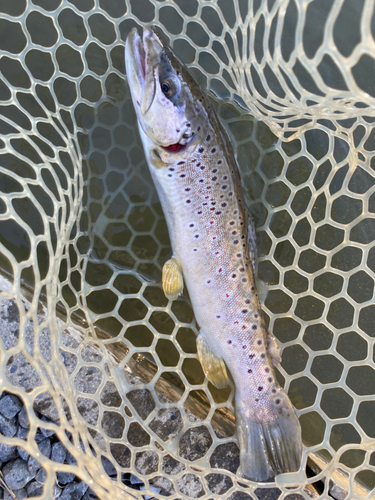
[125,26,303,482]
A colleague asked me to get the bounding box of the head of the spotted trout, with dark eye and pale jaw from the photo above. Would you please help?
[125,27,205,154]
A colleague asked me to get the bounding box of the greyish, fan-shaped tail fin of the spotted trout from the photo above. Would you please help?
[236,395,302,482]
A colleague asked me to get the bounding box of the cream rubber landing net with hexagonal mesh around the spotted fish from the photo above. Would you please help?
[0,0,375,500]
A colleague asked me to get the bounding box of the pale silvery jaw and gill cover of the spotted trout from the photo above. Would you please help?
[125,28,192,149]
